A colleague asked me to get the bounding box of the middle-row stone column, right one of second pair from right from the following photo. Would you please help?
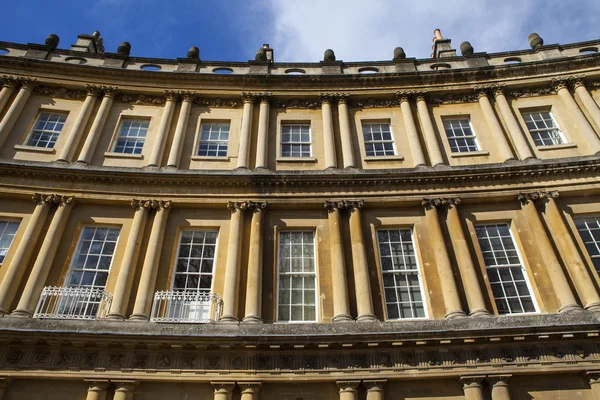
[442,197,490,317]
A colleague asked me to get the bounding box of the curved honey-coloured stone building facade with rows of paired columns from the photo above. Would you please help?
[0,32,600,400]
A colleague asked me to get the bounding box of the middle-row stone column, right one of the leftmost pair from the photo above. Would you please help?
[12,196,75,317]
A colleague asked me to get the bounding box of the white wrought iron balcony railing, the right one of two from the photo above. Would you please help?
[150,290,223,323]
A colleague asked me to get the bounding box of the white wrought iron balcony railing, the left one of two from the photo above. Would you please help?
[33,286,112,319]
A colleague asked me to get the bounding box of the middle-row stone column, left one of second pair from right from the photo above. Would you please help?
[421,199,466,319]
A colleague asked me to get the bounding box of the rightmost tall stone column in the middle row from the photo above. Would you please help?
[538,192,600,311]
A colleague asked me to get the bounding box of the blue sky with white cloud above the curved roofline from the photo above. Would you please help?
[0,0,600,61]
